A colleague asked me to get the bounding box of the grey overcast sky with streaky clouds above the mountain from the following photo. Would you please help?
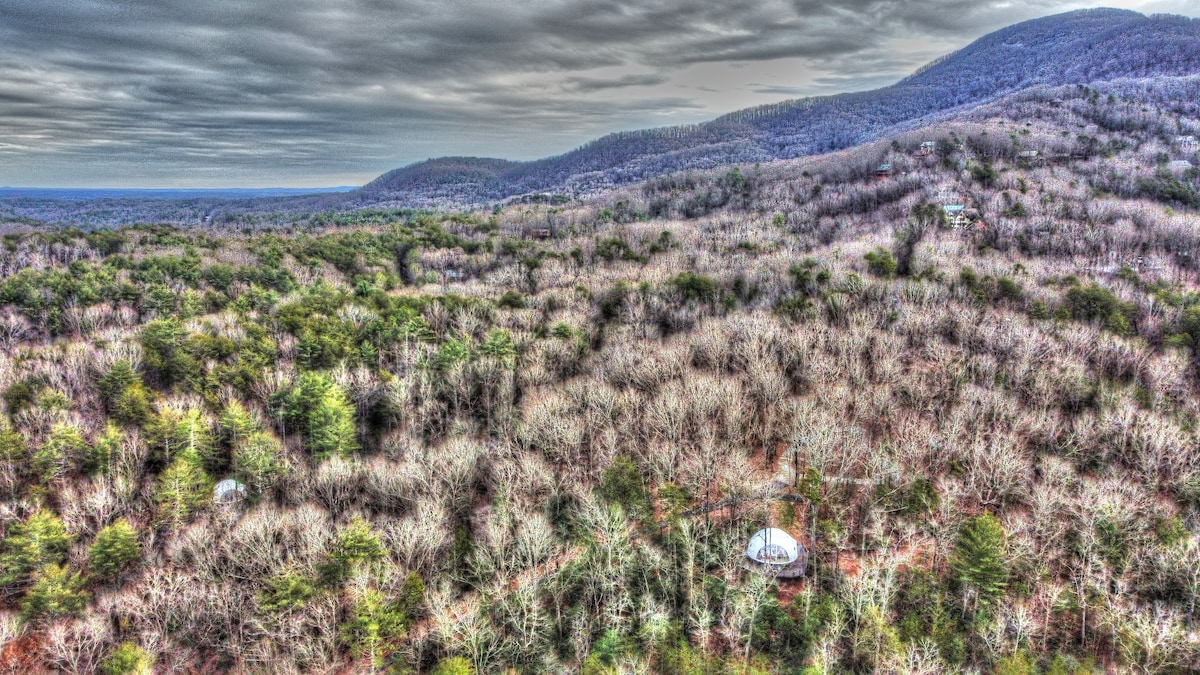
[0,0,1200,187]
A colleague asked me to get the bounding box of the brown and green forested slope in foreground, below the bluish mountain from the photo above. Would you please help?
[0,77,1200,675]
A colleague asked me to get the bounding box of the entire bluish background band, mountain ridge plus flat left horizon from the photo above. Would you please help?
[0,10,1200,225]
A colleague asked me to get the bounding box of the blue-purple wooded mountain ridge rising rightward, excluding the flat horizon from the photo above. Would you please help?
[360,10,1200,205]
